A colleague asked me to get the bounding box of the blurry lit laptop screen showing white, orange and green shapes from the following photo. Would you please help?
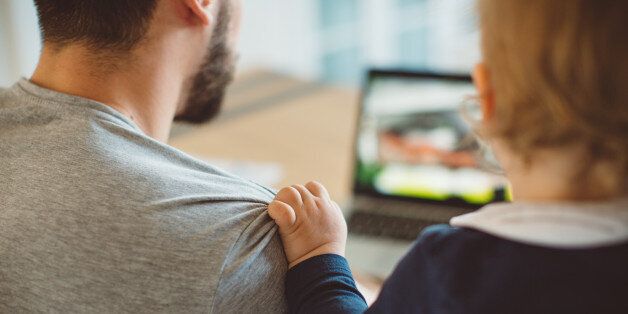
[355,71,508,207]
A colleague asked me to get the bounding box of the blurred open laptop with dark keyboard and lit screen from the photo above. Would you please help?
[348,70,509,244]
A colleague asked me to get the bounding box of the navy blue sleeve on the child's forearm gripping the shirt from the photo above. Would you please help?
[286,254,368,314]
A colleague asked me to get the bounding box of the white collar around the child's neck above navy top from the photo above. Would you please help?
[450,199,628,249]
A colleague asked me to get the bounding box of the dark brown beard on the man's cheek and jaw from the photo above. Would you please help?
[175,1,235,124]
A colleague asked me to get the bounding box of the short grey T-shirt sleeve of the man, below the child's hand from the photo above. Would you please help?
[212,213,288,313]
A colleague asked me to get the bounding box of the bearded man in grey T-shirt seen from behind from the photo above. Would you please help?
[0,0,286,313]
